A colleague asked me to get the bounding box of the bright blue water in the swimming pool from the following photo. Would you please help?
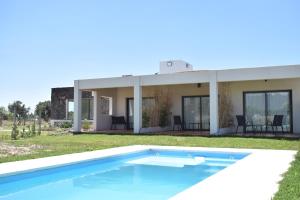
[0,150,248,200]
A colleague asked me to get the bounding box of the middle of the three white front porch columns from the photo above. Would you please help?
[133,77,142,133]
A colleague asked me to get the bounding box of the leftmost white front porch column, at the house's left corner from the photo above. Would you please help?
[73,81,82,133]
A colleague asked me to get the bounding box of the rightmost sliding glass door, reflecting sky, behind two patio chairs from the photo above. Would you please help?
[244,90,292,132]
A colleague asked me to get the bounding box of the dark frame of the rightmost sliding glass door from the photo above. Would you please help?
[243,89,294,133]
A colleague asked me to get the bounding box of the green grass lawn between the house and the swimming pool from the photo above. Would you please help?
[0,134,300,200]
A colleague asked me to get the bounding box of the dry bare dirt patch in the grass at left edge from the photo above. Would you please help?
[0,142,43,158]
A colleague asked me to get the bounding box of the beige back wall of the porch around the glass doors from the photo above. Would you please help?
[92,78,300,133]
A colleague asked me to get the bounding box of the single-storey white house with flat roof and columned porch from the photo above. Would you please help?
[54,60,300,134]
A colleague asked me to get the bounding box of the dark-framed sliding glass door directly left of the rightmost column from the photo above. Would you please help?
[182,96,209,130]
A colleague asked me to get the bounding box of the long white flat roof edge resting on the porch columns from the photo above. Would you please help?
[75,65,300,90]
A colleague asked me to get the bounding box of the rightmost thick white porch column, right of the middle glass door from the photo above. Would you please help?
[209,71,219,134]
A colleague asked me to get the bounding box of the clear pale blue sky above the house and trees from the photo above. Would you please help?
[0,0,300,111]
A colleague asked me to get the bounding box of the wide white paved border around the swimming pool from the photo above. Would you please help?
[0,145,296,200]
